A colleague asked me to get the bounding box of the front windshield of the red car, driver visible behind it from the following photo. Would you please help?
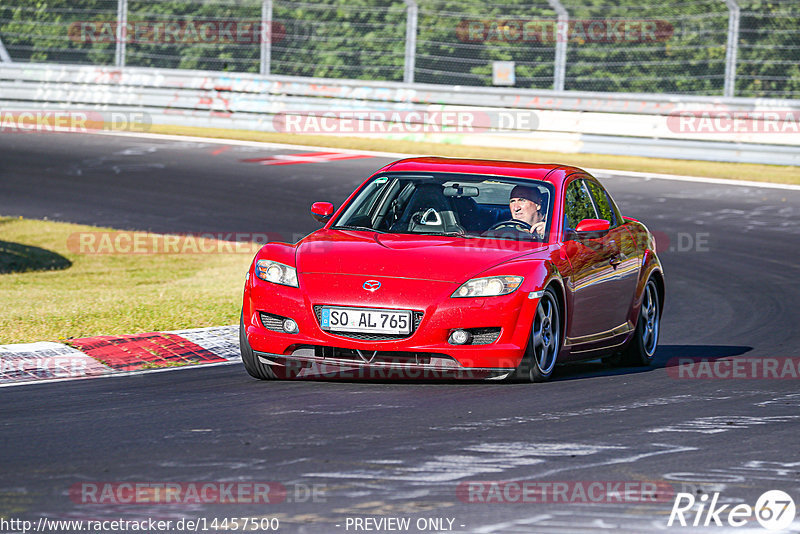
[332,173,553,241]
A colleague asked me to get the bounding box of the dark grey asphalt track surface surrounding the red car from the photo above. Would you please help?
[0,134,800,533]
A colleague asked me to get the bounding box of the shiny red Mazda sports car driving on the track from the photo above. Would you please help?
[240,158,664,382]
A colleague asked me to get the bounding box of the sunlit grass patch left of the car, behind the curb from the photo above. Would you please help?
[0,217,250,344]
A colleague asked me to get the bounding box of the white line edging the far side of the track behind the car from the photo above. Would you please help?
[91,132,800,191]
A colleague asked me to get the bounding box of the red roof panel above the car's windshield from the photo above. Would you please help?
[379,157,589,185]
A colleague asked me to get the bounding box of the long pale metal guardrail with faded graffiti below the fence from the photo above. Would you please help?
[0,63,800,165]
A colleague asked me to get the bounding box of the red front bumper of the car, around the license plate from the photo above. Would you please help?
[243,277,538,372]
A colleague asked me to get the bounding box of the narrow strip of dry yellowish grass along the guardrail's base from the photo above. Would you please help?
[150,125,800,184]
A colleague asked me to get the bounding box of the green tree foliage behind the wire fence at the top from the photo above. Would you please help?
[0,0,800,98]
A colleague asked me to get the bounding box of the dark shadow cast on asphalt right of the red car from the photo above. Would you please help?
[551,345,753,382]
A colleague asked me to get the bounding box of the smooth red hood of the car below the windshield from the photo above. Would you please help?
[296,229,547,282]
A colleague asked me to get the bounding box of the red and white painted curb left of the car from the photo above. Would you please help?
[0,326,241,387]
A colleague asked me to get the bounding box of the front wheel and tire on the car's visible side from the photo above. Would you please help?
[509,287,562,382]
